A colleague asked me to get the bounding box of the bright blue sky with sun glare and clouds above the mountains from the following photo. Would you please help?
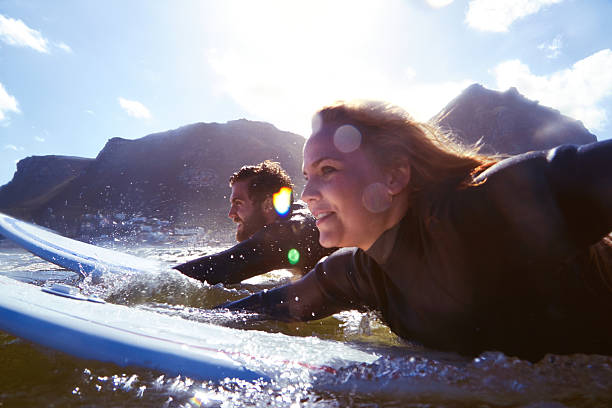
[0,0,612,185]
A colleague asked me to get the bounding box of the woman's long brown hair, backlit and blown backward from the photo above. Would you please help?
[313,100,499,192]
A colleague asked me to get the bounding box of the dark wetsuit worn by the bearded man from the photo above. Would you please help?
[174,201,333,285]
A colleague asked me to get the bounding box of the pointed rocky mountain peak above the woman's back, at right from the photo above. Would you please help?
[431,84,597,154]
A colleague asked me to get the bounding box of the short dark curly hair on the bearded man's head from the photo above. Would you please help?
[229,160,294,204]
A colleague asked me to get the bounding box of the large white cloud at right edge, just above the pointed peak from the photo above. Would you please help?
[494,49,612,131]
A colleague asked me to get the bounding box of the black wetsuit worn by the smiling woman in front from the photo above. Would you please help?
[221,141,612,360]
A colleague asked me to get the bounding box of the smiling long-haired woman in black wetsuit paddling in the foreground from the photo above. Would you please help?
[222,102,612,360]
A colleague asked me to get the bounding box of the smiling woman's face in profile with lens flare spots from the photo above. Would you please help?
[302,124,391,250]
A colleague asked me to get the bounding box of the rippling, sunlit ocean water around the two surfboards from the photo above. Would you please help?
[0,242,612,408]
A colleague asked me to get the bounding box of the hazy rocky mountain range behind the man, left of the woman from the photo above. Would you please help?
[0,119,304,237]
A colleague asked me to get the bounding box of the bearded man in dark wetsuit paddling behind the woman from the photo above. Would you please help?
[174,160,335,284]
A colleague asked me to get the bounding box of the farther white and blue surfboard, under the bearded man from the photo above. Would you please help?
[0,213,168,276]
